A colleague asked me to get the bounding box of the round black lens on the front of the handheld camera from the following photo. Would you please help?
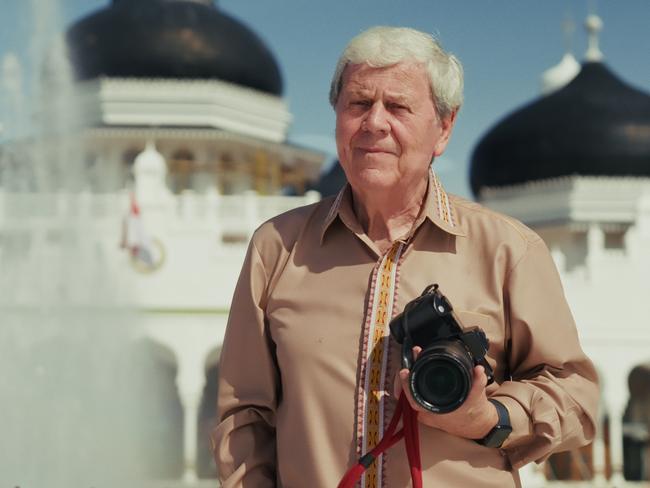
[410,341,474,413]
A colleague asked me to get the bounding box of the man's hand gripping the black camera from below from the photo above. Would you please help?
[395,346,499,439]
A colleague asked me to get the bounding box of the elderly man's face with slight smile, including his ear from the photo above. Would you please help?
[335,63,455,193]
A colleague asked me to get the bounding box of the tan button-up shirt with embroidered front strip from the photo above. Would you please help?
[213,176,598,488]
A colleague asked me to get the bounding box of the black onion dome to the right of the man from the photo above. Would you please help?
[470,62,650,195]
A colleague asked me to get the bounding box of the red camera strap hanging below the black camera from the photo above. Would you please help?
[338,393,422,488]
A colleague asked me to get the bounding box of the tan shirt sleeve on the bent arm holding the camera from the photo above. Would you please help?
[491,238,598,468]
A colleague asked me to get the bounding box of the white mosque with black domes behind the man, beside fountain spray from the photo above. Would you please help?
[0,0,650,487]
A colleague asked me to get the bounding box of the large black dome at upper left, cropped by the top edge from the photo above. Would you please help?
[67,0,282,95]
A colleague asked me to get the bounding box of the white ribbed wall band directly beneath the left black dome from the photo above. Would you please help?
[70,78,292,142]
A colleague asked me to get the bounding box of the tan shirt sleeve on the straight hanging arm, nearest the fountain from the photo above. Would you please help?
[212,241,279,488]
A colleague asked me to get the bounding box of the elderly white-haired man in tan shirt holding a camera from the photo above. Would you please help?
[214,27,597,488]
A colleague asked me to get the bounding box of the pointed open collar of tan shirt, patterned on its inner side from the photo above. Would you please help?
[320,169,466,244]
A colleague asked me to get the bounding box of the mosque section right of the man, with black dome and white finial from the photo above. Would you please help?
[470,15,650,480]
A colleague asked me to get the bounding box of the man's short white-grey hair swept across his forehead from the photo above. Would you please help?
[330,26,463,118]
